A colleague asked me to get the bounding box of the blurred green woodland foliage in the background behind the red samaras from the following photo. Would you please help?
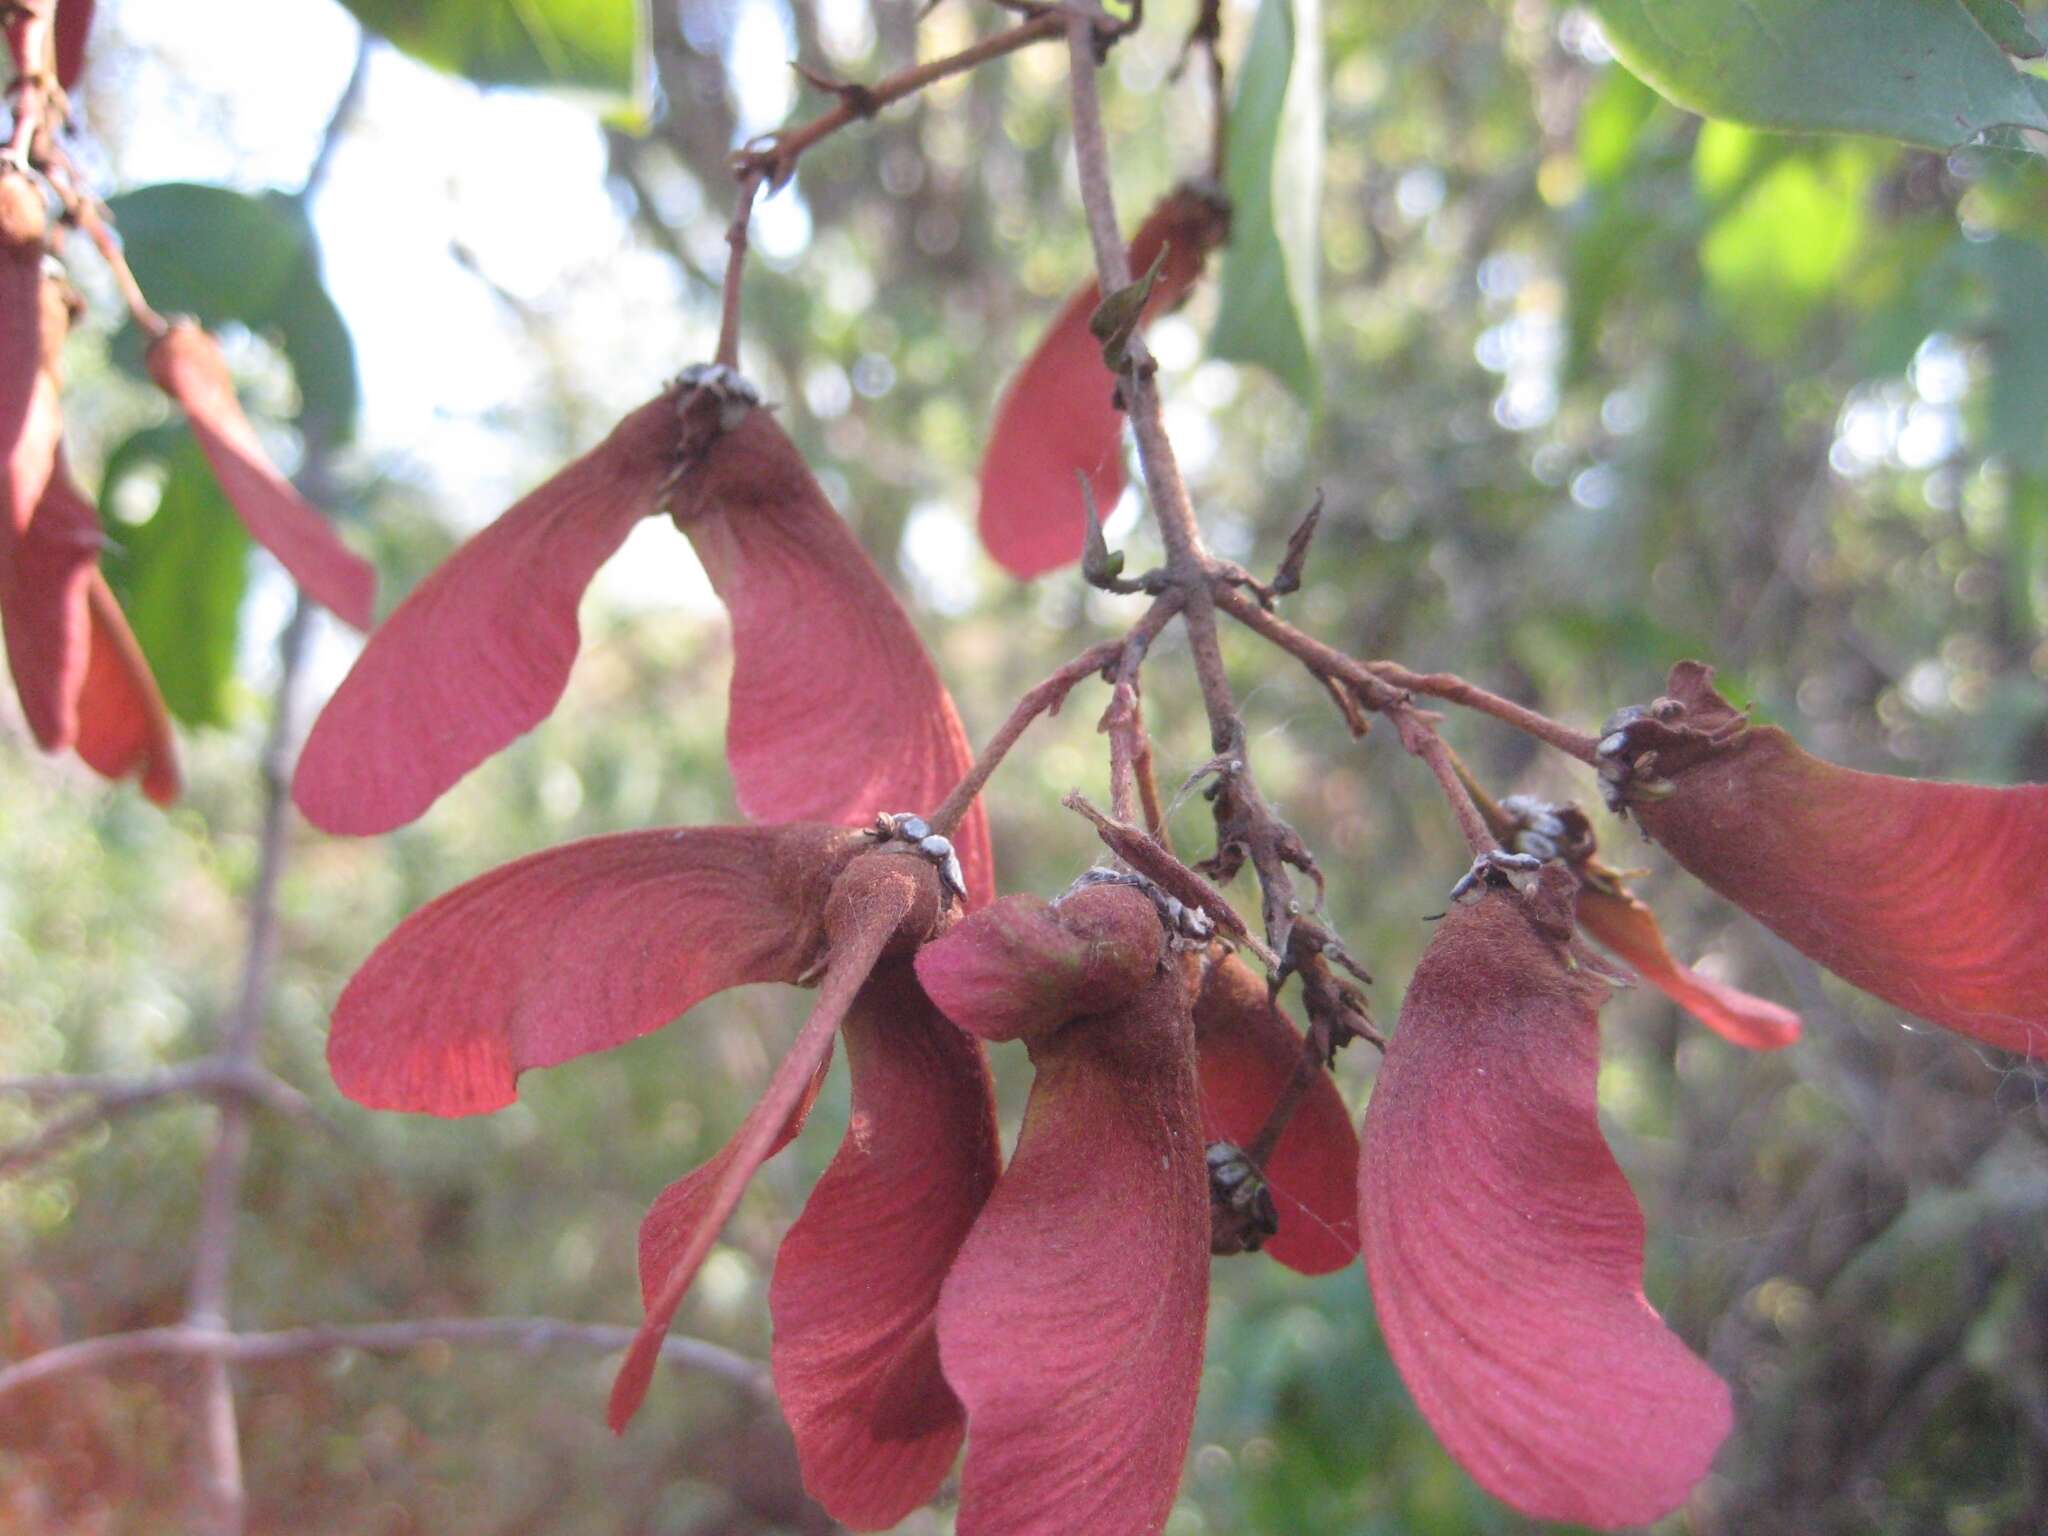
[0,0,2048,1536]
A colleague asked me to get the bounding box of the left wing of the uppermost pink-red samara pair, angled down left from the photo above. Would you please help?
[291,393,676,836]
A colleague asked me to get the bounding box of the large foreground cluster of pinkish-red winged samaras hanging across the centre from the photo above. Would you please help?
[295,294,2048,1536]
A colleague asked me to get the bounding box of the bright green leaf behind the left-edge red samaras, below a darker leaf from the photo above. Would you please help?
[100,426,250,725]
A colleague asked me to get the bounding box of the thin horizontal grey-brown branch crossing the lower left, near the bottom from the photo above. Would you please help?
[0,1317,774,1399]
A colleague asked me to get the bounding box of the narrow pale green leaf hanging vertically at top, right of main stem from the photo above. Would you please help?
[1208,0,1323,410]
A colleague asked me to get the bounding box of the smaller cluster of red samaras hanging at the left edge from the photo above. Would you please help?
[0,138,377,803]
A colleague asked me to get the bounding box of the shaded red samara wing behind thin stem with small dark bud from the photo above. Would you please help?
[1194,954,1358,1274]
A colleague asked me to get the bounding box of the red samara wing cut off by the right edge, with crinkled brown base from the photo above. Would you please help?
[1622,662,2048,1055]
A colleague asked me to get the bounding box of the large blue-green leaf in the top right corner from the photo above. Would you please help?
[1591,0,2048,150]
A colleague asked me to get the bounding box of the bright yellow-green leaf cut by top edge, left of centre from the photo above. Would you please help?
[342,0,641,96]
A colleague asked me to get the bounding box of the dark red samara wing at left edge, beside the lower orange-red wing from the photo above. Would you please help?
[0,451,104,752]
